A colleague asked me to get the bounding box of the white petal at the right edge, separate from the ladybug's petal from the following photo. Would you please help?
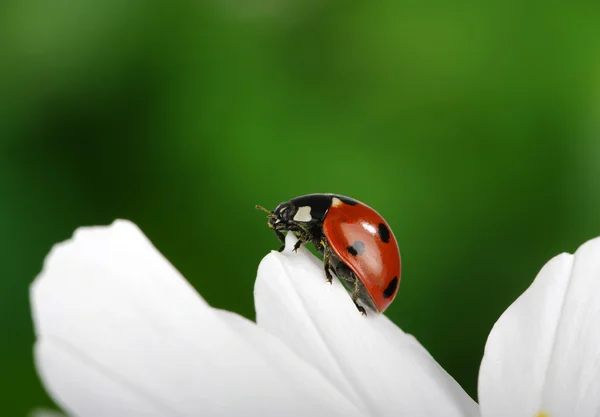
[479,238,600,417]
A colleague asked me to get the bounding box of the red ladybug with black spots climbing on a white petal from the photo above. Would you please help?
[256,194,402,315]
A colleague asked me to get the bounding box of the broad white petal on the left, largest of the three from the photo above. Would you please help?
[31,221,356,417]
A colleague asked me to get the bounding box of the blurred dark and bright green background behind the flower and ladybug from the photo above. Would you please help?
[0,0,600,416]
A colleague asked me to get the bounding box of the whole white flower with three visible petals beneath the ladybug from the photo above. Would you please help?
[31,221,600,417]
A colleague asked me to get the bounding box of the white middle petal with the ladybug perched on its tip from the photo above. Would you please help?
[255,233,478,417]
